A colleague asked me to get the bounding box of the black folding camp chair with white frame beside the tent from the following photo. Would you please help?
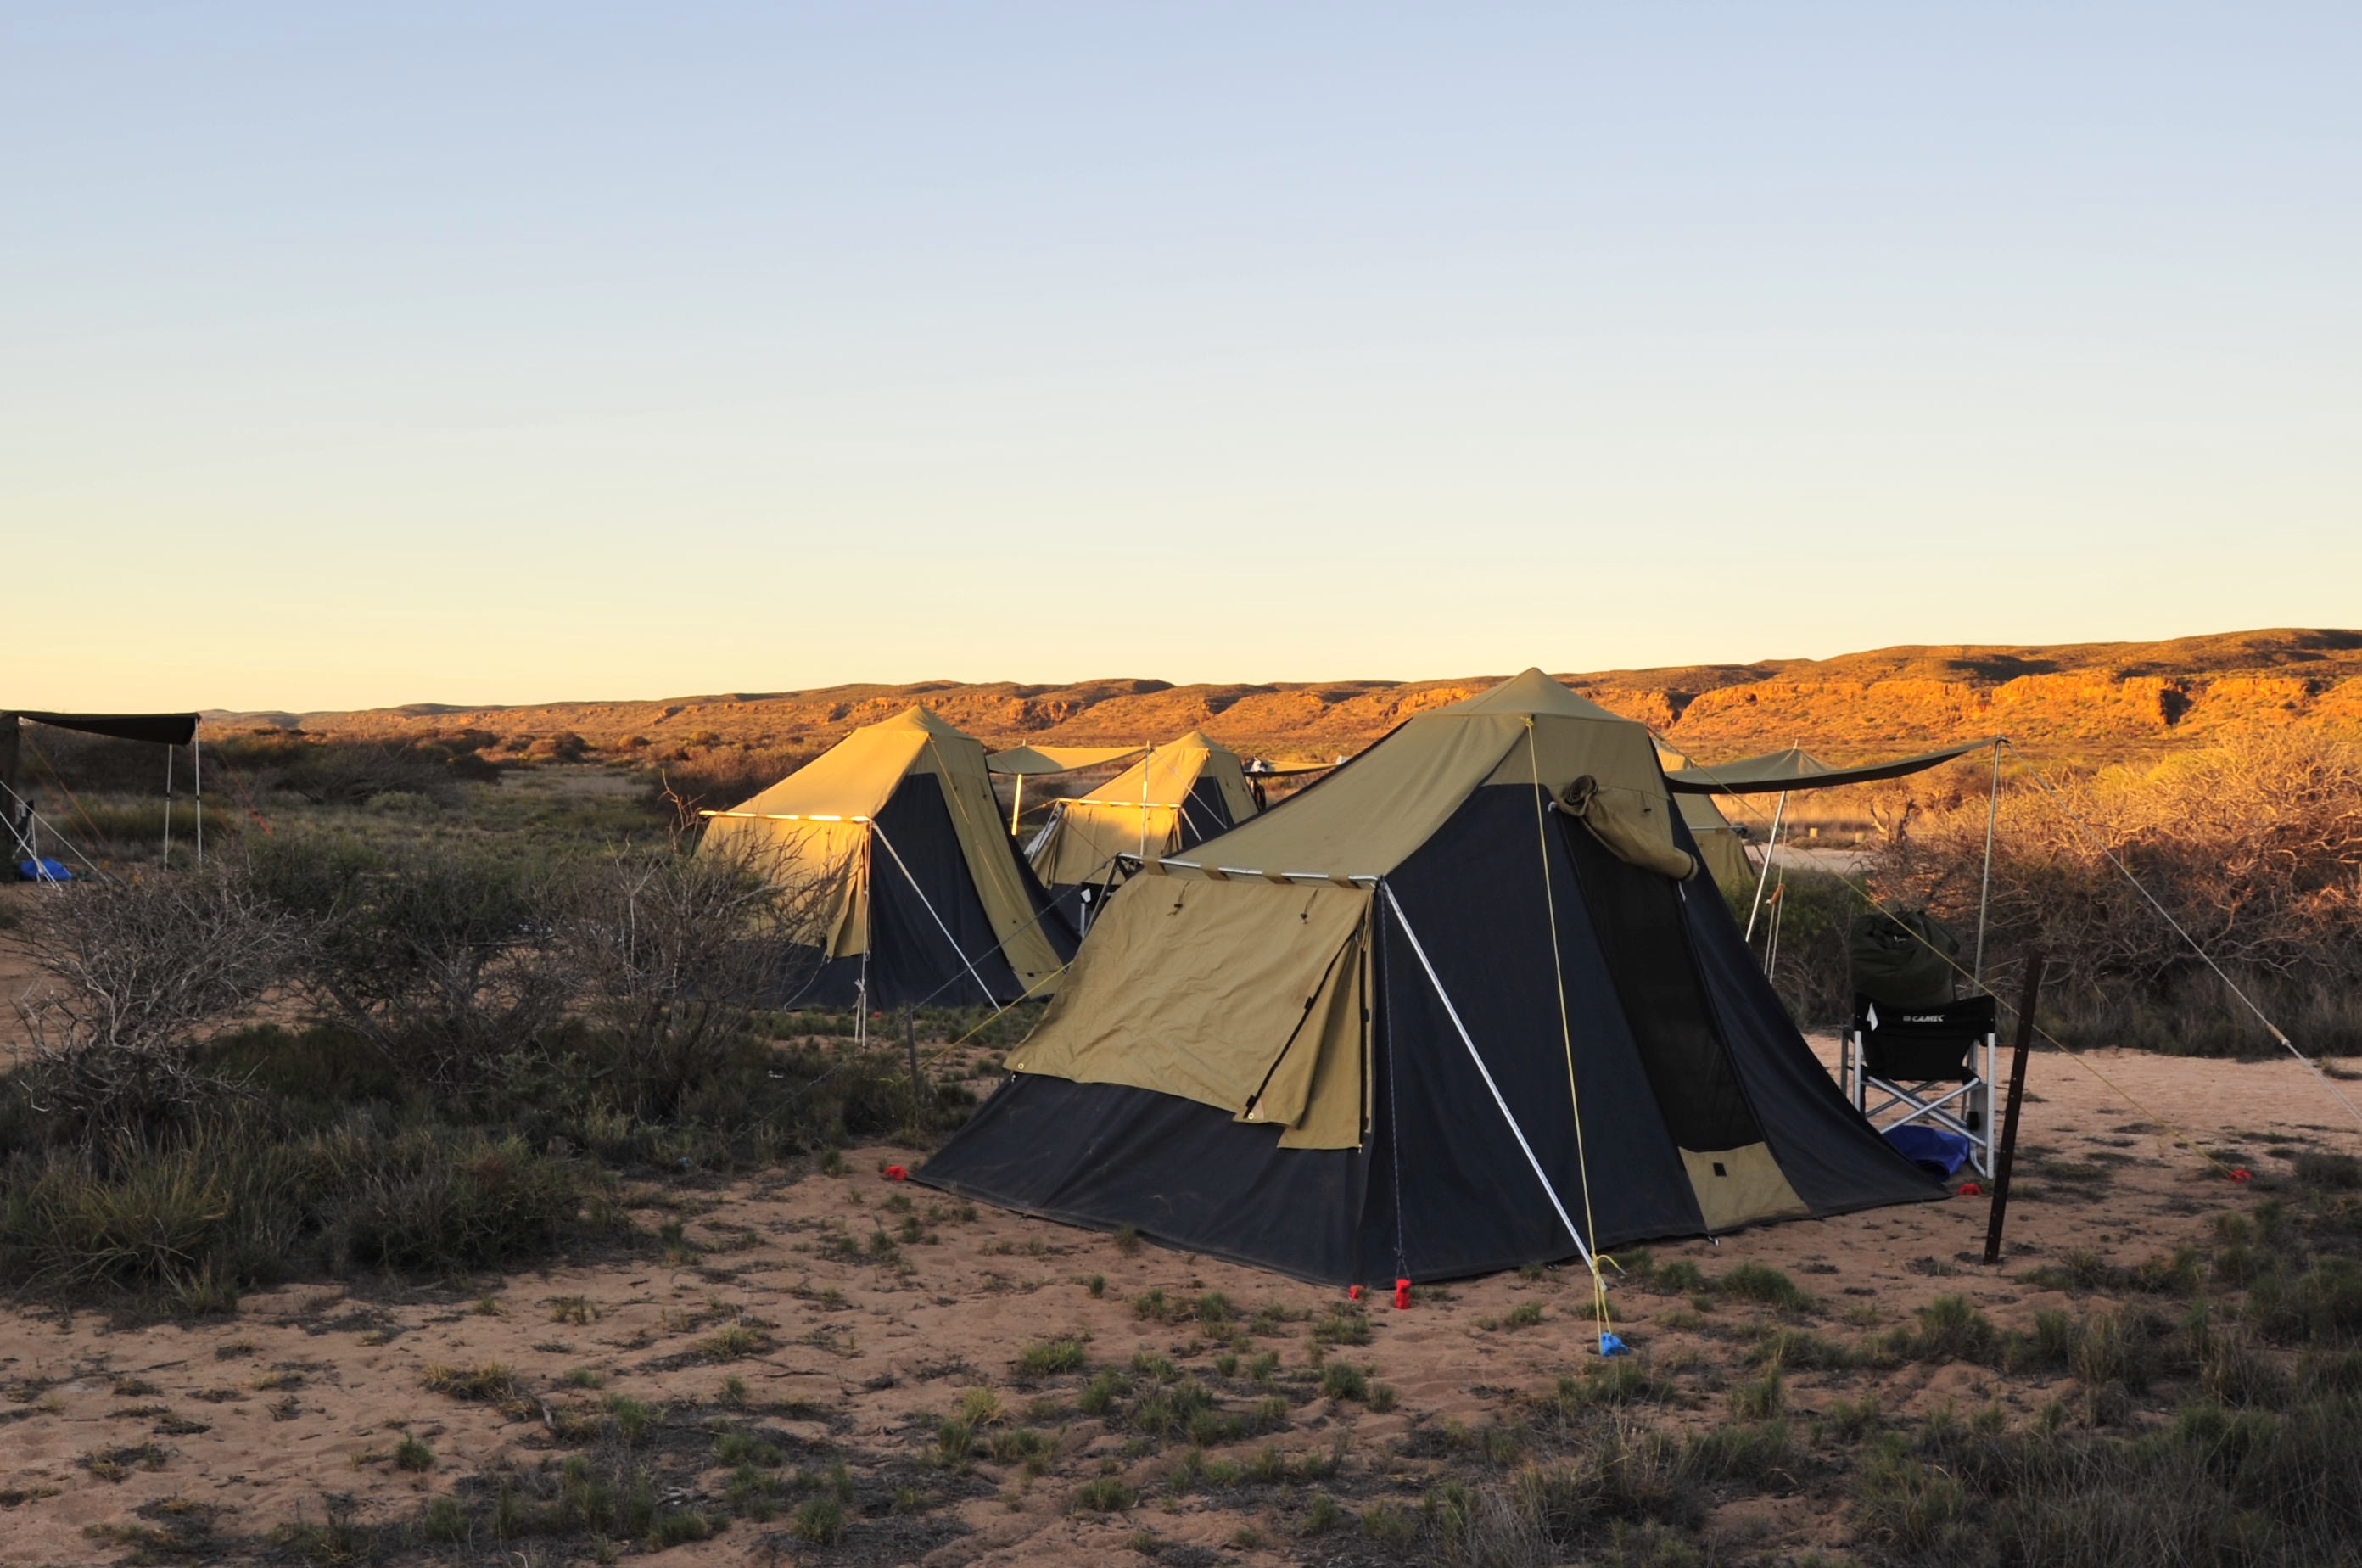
[1838,992,2001,1176]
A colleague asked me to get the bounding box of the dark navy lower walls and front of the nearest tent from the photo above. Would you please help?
[919,784,1941,1285]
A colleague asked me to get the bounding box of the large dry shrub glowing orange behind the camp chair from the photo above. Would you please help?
[1875,730,2362,1050]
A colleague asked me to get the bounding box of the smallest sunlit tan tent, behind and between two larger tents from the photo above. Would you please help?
[1025,730,1257,907]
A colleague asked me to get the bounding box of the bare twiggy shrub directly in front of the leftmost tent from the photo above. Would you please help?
[567,848,843,1117]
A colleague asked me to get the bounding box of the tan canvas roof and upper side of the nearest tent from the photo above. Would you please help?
[1009,670,1691,1148]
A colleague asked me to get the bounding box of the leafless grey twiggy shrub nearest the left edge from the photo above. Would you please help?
[16,862,307,1140]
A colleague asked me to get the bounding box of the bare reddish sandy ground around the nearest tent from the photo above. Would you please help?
[0,1041,2362,1565]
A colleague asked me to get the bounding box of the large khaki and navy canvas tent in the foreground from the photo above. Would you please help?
[921,670,1941,1282]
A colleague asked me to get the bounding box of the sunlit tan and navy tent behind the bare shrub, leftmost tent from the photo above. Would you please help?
[704,706,1075,1006]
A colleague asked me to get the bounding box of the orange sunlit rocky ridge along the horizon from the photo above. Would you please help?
[208,630,2362,760]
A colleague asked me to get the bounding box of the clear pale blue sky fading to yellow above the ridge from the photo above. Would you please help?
[0,0,2362,708]
